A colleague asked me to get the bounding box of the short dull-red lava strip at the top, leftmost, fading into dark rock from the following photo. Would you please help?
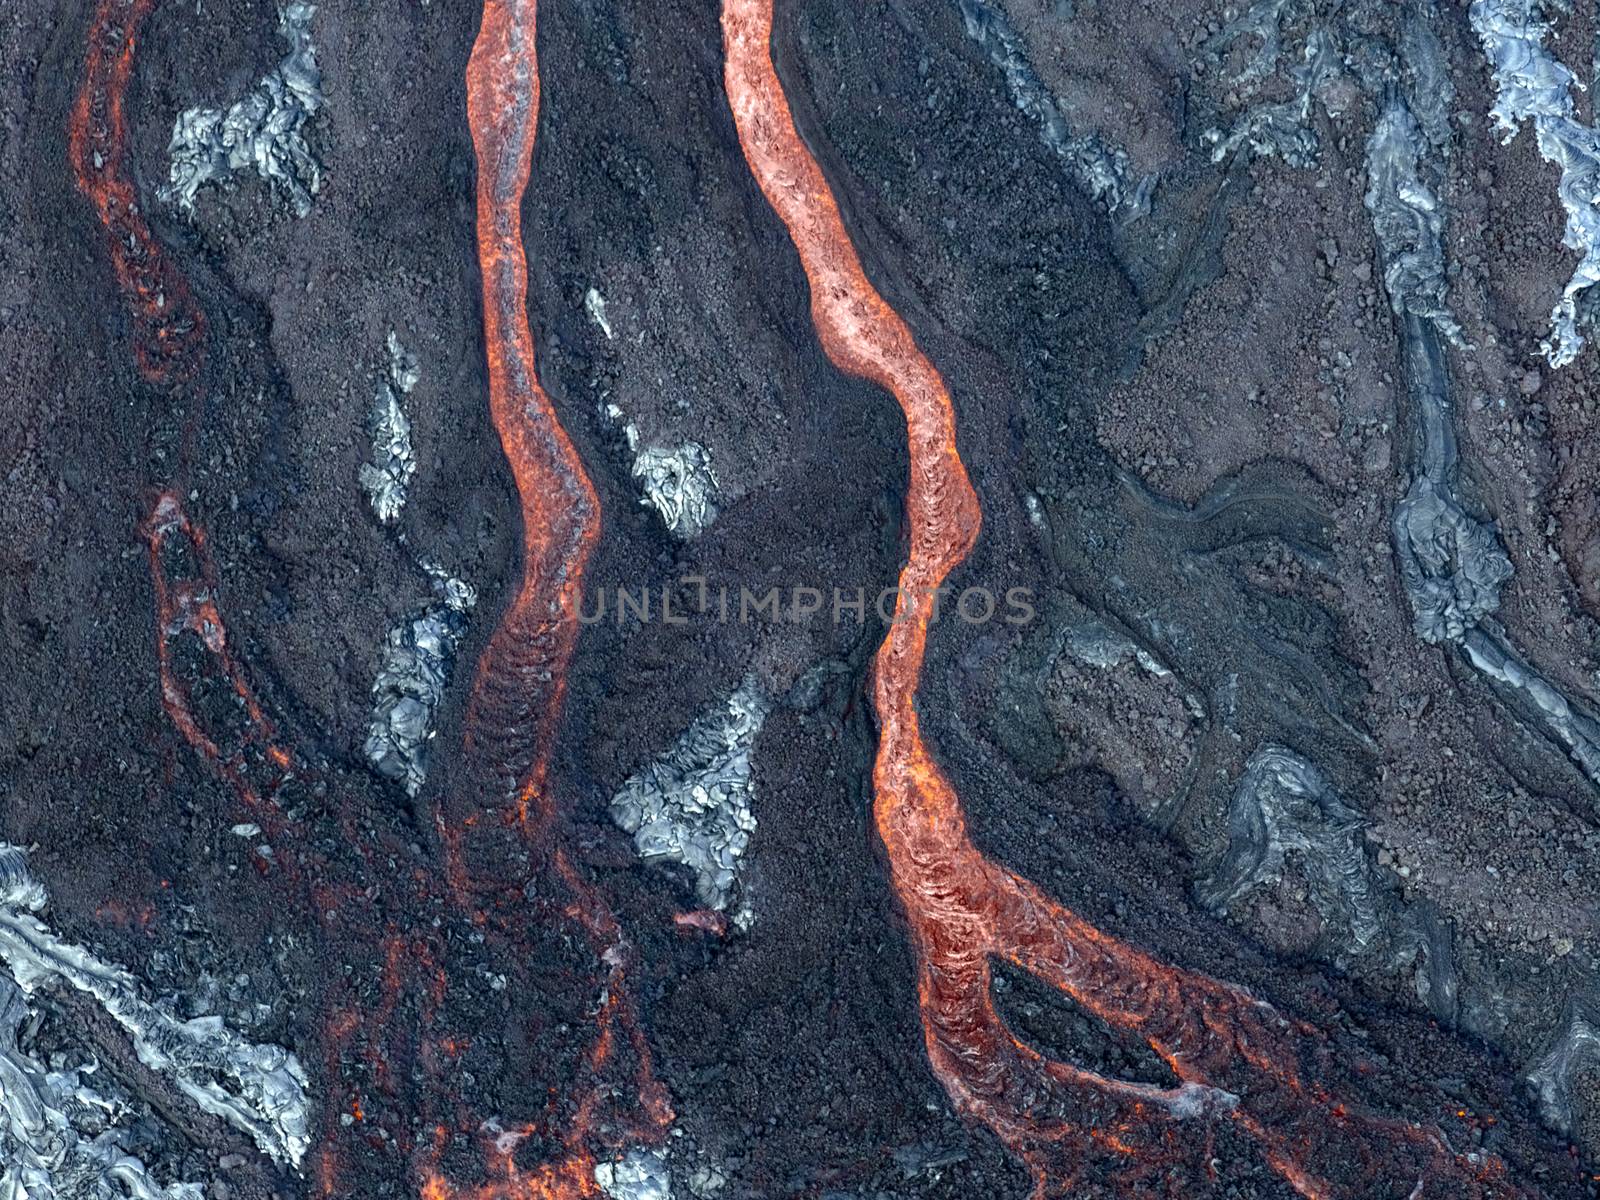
[67,0,205,382]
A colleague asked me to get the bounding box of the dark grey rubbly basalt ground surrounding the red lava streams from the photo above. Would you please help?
[9,0,1600,1200]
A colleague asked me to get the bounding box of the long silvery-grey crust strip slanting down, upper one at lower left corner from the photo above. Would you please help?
[0,843,310,1166]
